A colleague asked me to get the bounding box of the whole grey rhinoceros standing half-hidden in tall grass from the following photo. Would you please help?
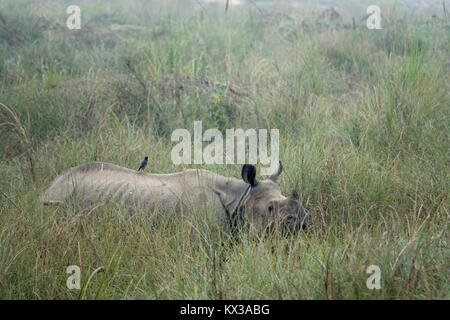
[40,161,308,231]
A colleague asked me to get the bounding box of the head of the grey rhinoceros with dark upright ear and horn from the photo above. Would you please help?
[236,161,309,232]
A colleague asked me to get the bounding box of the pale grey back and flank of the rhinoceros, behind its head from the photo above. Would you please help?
[41,162,226,220]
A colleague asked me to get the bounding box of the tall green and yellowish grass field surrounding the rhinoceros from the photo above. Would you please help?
[0,0,450,299]
